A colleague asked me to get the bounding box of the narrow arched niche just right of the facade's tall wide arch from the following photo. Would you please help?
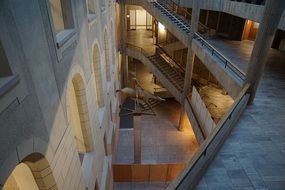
[93,44,104,108]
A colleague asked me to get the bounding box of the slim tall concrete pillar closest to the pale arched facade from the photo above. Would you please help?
[120,0,128,88]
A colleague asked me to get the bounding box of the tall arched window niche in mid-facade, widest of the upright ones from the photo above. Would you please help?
[68,74,93,157]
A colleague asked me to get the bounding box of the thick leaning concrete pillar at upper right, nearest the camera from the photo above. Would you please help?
[246,0,285,104]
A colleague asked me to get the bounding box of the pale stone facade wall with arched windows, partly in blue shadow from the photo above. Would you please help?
[0,0,120,190]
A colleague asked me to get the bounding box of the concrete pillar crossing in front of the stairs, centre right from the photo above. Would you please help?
[183,0,200,97]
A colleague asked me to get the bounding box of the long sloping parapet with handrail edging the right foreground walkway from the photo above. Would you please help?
[168,84,250,190]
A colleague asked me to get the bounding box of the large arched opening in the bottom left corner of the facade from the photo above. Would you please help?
[3,153,58,190]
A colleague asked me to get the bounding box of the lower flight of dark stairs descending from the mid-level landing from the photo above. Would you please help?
[148,53,184,93]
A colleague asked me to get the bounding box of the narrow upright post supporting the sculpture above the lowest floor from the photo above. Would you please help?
[133,115,141,164]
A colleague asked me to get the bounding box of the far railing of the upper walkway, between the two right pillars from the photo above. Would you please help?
[194,33,245,81]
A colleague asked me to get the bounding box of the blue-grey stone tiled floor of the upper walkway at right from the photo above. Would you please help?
[196,41,285,190]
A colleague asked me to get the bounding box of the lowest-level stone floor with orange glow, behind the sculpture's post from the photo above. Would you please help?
[116,99,198,163]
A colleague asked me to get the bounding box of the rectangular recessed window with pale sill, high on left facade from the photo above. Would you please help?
[49,0,74,47]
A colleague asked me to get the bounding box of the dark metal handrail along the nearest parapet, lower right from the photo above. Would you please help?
[173,84,250,187]
